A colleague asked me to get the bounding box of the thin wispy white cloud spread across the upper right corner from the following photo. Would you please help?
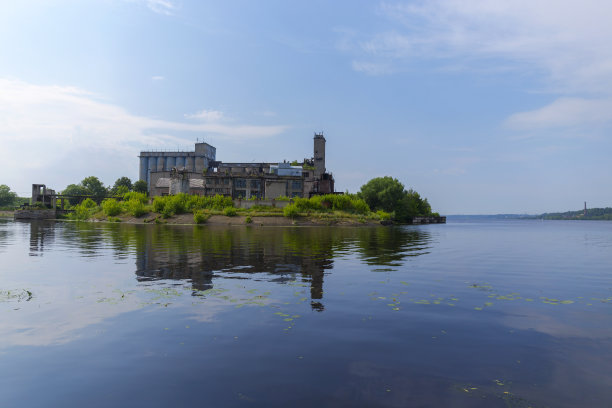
[368,0,612,92]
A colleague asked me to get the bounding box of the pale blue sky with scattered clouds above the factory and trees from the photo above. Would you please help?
[0,0,612,214]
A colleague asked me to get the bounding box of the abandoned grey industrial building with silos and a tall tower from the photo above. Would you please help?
[139,133,334,200]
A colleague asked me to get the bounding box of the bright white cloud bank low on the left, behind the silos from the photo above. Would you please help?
[0,78,287,192]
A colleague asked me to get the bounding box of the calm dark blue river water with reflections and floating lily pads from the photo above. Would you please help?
[0,220,612,407]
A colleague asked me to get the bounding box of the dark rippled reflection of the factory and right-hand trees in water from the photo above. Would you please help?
[135,226,430,311]
